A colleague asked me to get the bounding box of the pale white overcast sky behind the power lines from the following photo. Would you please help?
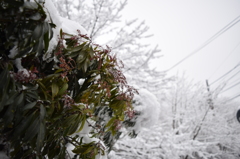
[123,0,240,99]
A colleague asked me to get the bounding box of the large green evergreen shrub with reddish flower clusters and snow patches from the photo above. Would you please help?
[0,0,137,158]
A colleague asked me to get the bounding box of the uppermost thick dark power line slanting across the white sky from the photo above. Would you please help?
[166,15,240,71]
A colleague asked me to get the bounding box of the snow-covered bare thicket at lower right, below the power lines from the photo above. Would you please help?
[109,77,240,159]
